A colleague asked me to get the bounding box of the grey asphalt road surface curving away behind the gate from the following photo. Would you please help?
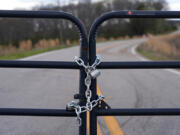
[0,39,180,135]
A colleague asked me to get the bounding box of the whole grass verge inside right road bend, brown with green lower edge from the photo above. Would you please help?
[136,33,180,61]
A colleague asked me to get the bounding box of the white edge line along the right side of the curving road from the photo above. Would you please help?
[131,45,180,75]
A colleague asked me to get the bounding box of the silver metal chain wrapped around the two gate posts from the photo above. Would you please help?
[68,56,104,126]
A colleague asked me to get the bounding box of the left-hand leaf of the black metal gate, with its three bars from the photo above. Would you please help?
[0,10,88,135]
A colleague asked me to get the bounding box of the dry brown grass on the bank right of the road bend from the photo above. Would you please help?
[138,34,180,59]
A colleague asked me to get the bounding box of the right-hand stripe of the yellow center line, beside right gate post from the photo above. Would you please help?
[97,86,124,135]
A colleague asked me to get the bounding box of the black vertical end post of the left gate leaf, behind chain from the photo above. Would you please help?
[79,35,88,135]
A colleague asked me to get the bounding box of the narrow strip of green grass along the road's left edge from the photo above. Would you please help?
[0,45,74,60]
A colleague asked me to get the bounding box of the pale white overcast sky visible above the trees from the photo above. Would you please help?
[0,0,180,10]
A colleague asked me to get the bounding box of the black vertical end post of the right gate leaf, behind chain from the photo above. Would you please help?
[89,37,97,135]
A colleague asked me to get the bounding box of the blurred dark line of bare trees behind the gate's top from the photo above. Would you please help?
[0,0,176,47]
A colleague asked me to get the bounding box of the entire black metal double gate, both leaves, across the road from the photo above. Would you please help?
[0,10,180,135]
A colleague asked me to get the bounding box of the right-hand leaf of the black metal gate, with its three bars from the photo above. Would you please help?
[89,11,180,135]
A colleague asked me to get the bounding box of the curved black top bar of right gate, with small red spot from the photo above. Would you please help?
[89,11,180,67]
